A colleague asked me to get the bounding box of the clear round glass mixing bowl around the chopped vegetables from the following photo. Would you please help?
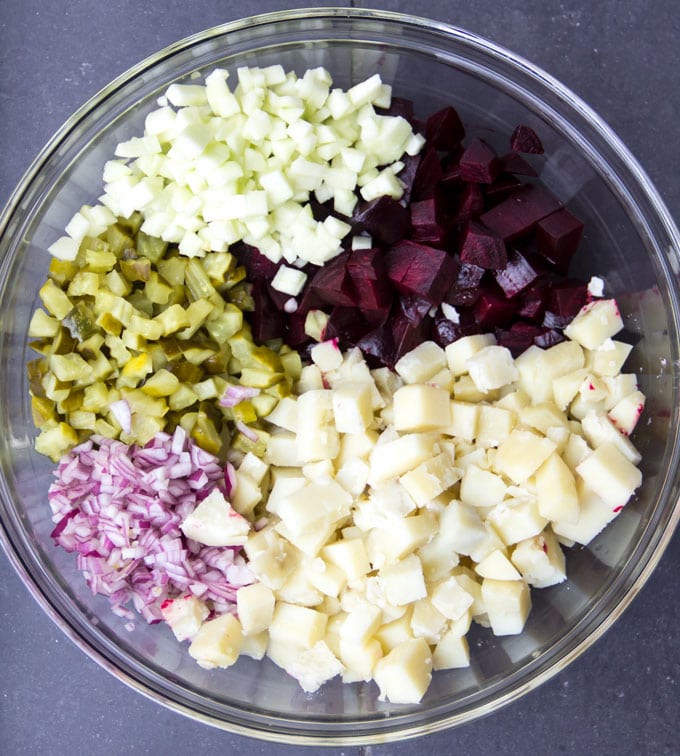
[0,9,680,744]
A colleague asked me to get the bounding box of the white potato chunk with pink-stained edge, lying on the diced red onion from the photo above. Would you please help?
[180,488,250,546]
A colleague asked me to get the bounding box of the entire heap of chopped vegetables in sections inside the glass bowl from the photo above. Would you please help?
[28,66,645,703]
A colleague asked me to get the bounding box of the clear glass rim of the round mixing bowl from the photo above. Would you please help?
[0,7,680,746]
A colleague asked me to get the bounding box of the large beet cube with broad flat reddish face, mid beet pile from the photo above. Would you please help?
[385,240,457,305]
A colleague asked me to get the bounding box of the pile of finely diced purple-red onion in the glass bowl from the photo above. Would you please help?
[49,426,254,627]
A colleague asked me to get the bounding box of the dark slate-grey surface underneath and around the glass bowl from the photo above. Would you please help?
[0,0,680,756]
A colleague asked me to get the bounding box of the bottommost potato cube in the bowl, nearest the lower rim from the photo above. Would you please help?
[373,638,432,704]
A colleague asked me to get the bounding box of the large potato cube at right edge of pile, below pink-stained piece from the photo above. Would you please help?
[576,443,642,509]
